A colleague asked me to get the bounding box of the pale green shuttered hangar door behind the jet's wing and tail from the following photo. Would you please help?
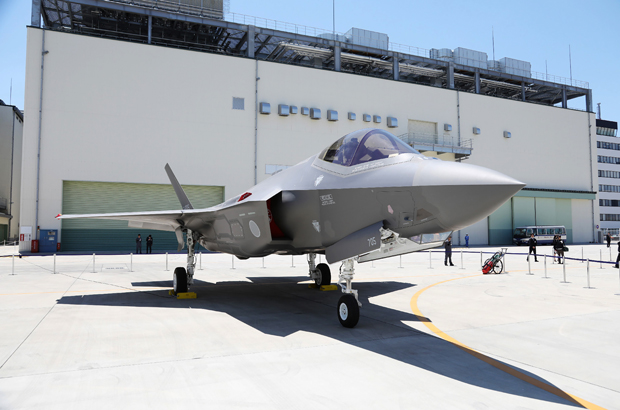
[60,181,224,253]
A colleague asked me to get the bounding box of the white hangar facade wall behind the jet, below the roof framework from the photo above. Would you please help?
[20,0,599,251]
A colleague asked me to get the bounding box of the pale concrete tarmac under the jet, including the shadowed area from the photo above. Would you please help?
[0,245,620,410]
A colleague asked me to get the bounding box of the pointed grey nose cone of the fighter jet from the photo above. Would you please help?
[413,161,525,231]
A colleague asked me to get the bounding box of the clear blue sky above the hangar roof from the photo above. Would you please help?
[0,0,620,121]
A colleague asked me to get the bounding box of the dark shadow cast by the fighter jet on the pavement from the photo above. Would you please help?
[58,276,582,407]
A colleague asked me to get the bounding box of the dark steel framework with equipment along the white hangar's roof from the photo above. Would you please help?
[32,0,592,112]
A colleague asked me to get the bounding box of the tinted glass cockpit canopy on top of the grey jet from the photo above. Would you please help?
[319,128,421,167]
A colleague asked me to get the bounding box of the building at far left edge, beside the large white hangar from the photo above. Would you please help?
[0,100,24,243]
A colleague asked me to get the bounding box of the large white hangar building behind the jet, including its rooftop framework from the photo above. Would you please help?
[20,0,599,251]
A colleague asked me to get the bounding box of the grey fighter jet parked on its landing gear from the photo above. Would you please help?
[58,128,525,327]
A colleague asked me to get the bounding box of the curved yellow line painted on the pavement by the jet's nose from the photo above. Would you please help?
[410,274,605,410]
